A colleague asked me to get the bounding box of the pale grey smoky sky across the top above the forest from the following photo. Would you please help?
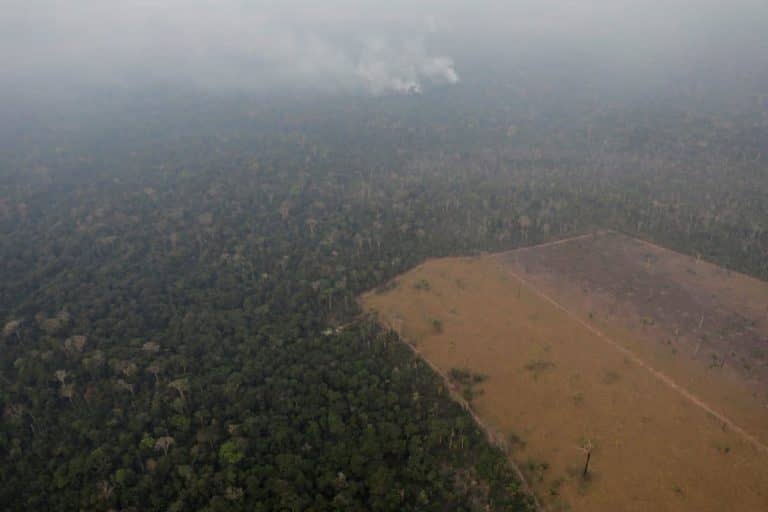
[0,0,768,98]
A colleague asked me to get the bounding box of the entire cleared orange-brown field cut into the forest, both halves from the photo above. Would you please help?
[362,232,768,511]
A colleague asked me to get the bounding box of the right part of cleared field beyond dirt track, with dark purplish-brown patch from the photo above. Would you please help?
[508,232,768,445]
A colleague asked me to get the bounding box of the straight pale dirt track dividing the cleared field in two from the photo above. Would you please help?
[504,266,768,454]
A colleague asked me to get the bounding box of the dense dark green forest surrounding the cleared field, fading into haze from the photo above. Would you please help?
[0,85,768,511]
